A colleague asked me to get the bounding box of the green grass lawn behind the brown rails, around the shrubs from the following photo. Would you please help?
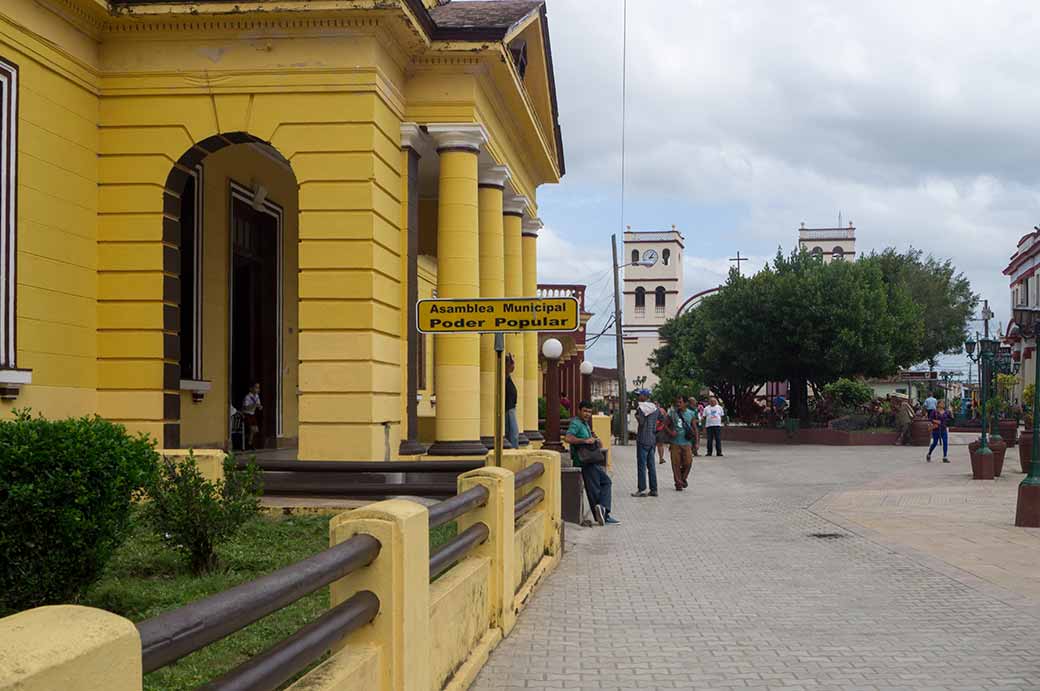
[79,505,457,691]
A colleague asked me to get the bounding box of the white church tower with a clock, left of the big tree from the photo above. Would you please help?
[619,226,683,388]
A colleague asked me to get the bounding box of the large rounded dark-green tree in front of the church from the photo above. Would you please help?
[651,251,924,419]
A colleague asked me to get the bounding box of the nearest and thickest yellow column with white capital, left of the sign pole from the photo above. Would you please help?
[426,124,488,456]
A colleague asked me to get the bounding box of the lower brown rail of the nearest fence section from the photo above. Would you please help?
[199,590,380,691]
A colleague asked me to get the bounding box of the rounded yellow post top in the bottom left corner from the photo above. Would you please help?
[0,605,142,691]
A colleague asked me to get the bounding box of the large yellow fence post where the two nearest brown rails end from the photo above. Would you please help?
[329,500,431,691]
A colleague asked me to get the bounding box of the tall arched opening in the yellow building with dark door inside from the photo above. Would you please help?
[164,132,298,449]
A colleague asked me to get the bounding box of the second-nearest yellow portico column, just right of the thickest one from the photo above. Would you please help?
[477,165,510,449]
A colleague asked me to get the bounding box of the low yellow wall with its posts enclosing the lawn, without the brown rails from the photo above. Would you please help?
[0,450,561,691]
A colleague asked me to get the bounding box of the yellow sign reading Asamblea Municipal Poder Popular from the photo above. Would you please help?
[415,298,580,333]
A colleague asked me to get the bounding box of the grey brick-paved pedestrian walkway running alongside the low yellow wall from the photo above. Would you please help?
[473,443,1040,691]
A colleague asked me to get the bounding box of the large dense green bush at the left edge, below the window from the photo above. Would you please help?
[0,410,158,610]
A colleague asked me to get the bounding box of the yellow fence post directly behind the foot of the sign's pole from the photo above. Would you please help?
[459,467,517,636]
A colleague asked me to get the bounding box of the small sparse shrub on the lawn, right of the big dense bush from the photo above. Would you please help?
[144,454,261,575]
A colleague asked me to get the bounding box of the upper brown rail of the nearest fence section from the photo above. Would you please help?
[137,535,382,673]
